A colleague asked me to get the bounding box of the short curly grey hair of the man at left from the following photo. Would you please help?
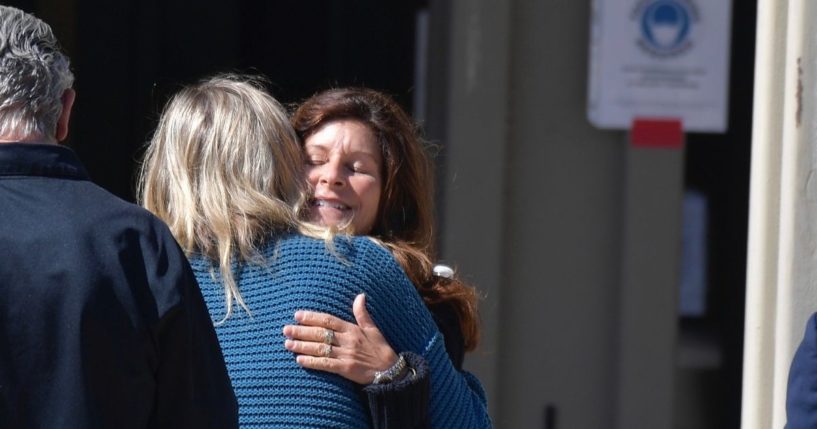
[0,6,74,138]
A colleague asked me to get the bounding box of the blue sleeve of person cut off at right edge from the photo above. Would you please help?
[786,314,817,429]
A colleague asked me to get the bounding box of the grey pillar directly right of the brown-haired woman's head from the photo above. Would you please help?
[432,0,510,412]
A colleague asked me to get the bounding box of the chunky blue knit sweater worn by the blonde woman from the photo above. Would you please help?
[191,235,491,428]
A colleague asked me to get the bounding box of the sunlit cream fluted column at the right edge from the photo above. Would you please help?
[742,0,817,429]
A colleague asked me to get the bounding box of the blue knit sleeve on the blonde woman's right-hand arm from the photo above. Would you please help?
[352,244,491,429]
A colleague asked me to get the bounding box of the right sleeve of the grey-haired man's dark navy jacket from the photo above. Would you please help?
[143,226,238,428]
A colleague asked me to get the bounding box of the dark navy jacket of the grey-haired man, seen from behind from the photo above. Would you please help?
[0,143,237,428]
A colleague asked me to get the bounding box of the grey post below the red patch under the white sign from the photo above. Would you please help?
[615,142,684,429]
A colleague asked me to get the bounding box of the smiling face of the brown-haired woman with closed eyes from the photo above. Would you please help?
[304,119,383,235]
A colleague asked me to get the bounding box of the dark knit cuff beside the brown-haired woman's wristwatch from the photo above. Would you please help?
[363,352,431,429]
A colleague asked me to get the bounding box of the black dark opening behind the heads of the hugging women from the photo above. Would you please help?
[11,0,425,200]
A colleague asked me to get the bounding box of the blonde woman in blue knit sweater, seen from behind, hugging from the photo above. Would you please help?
[139,76,490,428]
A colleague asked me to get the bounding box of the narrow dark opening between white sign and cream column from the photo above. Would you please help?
[677,2,757,429]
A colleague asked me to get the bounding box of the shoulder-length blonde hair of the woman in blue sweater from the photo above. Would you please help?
[138,75,305,322]
